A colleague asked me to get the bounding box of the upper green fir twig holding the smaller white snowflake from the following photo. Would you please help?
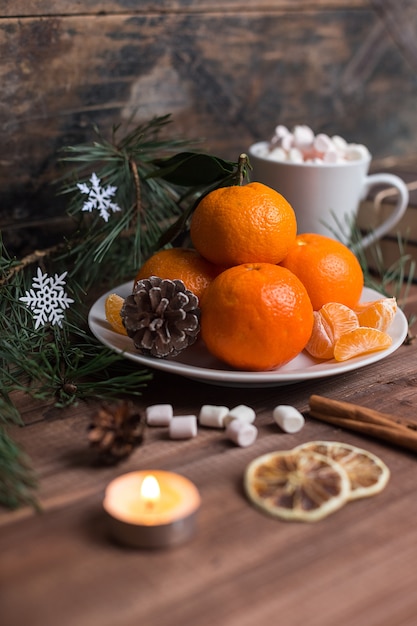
[57,116,192,282]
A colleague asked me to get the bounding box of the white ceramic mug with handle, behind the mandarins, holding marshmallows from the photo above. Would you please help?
[248,141,409,248]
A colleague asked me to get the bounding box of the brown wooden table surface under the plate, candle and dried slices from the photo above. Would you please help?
[0,289,417,626]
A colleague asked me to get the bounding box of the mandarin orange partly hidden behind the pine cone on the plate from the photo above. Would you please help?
[135,248,223,300]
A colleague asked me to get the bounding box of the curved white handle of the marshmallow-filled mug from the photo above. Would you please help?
[360,172,409,248]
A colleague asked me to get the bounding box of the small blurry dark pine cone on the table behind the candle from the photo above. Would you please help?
[88,402,144,465]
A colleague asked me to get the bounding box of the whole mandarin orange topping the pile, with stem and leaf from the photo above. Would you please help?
[190,183,297,267]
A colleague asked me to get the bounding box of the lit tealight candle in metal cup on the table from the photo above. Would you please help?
[103,470,200,548]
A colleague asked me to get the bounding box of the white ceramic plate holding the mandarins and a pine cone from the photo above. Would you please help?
[88,282,408,387]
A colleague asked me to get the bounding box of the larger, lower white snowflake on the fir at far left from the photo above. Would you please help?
[19,267,74,329]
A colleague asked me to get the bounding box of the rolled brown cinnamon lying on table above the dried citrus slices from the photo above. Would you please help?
[310,395,417,452]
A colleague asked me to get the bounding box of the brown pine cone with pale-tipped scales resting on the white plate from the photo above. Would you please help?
[121,276,200,358]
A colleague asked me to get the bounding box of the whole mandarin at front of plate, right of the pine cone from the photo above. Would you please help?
[201,263,313,371]
